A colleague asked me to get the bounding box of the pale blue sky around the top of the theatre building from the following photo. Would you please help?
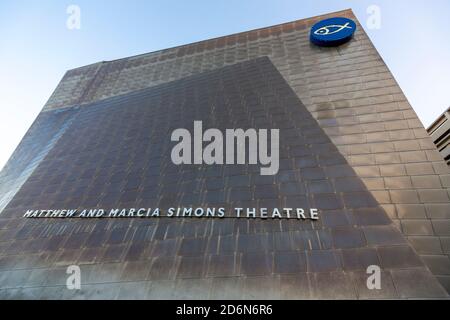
[0,0,450,168]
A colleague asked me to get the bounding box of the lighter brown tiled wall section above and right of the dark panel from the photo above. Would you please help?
[40,11,450,288]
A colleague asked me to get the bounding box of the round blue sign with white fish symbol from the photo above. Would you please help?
[310,17,356,47]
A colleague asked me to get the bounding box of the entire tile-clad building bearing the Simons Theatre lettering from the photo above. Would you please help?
[0,10,450,299]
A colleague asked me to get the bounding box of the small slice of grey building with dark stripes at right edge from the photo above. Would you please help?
[427,108,450,165]
